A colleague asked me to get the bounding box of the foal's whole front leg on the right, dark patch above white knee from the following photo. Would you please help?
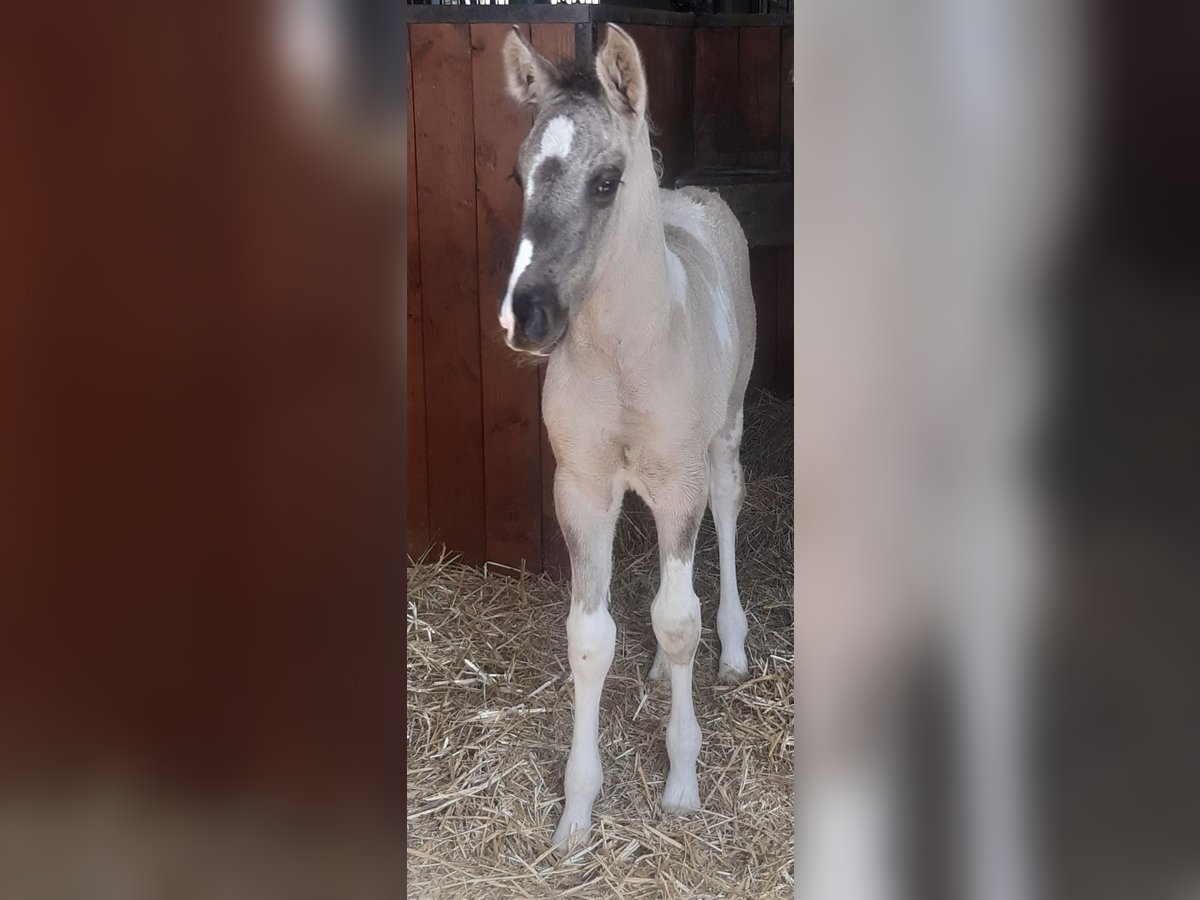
[650,484,708,811]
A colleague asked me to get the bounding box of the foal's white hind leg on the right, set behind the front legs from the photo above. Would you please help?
[708,409,750,684]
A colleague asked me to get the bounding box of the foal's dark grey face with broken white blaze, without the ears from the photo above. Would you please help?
[500,91,629,355]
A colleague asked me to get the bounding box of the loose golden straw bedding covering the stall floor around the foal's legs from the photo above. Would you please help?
[408,395,793,900]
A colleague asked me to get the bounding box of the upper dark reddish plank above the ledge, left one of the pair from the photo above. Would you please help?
[692,28,742,167]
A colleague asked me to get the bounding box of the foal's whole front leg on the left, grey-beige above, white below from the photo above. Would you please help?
[553,469,620,851]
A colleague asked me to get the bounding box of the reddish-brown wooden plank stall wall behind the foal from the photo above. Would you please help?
[408,22,791,571]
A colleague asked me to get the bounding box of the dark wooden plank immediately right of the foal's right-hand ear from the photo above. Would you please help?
[625,25,694,187]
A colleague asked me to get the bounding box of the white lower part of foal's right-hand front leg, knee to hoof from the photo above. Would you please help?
[650,559,700,811]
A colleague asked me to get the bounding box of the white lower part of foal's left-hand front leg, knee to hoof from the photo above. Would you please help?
[554,606,617,846]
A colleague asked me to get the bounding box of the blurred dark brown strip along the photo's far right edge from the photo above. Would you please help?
[1040,0,1200,900]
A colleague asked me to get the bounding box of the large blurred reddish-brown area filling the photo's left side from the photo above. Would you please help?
[0,2,406,821]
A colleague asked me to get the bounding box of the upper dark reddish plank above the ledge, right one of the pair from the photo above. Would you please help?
[737,26,781,169]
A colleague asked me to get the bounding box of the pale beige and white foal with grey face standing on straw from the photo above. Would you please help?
[499,25,755,848]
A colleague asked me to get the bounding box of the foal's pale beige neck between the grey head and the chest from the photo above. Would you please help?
[572,122,670,348]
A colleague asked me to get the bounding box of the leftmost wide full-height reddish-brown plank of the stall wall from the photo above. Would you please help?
[409,24,486,564]
